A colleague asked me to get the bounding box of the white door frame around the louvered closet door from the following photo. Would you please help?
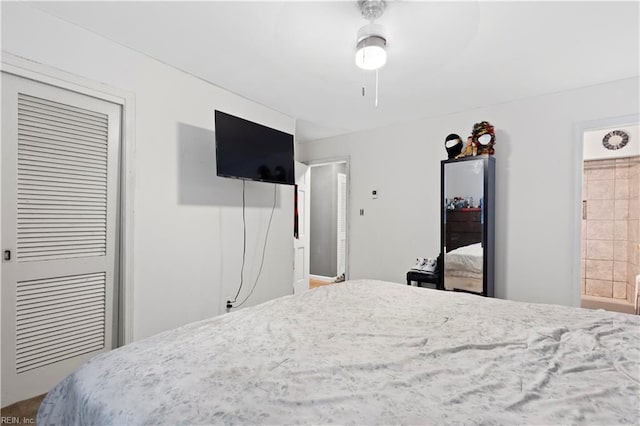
[0,51,135,347]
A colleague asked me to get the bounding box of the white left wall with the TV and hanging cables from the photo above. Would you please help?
[2,2,295,339]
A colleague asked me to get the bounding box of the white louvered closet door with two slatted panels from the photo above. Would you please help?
[2,73,120,406]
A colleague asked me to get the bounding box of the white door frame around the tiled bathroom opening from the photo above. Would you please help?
[571,114,640,307]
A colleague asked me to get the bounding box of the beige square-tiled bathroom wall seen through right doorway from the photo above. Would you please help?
[581,158,640,301]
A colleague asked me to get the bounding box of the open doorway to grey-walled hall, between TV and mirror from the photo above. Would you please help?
[309,160,349,288]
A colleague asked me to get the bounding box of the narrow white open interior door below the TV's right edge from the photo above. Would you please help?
[293,161,311,294]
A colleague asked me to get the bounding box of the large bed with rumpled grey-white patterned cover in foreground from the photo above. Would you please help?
[37,280,640,425]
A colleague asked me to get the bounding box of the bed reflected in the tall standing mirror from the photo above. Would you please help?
[444,243,483,293]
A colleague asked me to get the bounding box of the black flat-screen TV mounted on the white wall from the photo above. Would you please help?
[215,110,295,185]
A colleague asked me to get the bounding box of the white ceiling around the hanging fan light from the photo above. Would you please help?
[31,0,640,141]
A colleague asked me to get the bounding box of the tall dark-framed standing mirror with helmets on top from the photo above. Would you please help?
[440,155,495,297]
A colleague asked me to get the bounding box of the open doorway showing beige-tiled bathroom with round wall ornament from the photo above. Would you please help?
[580,123,640,313]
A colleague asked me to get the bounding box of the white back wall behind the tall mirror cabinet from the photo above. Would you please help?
[298,78,640,305]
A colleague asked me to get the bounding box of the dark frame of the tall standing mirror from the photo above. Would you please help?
[440,155,496,297]
